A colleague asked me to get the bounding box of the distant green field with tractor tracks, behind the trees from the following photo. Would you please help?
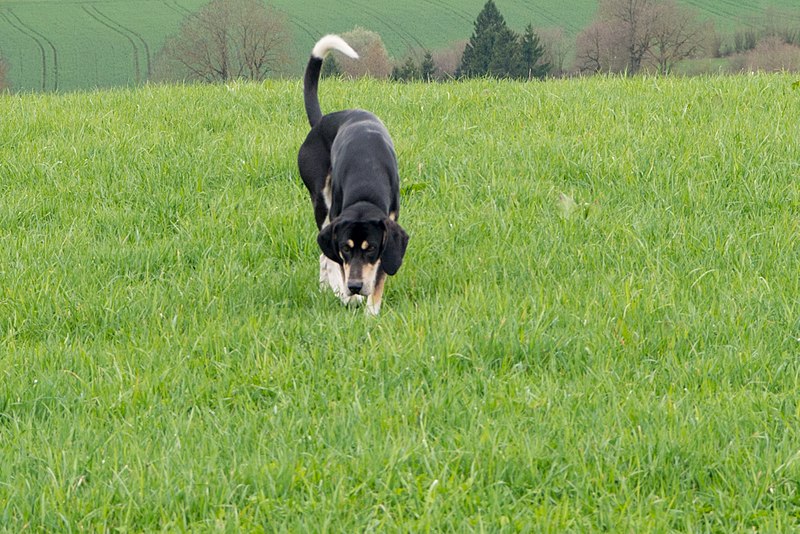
[0,0,800,91]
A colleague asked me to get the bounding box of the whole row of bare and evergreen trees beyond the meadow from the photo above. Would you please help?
[0,0,800,90]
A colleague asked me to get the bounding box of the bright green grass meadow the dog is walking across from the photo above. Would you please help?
[0,75,800,532]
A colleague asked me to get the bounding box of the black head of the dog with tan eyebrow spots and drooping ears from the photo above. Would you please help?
[317,216,408,296]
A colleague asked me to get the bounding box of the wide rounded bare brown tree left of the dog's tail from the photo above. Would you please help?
[157,0,291,82]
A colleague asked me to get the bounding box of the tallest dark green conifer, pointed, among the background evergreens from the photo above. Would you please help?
[456,0,522,78]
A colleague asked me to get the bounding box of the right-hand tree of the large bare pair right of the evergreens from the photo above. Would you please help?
[647,0,714,74]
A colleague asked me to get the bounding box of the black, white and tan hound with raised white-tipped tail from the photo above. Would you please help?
[297,35,408,315]
